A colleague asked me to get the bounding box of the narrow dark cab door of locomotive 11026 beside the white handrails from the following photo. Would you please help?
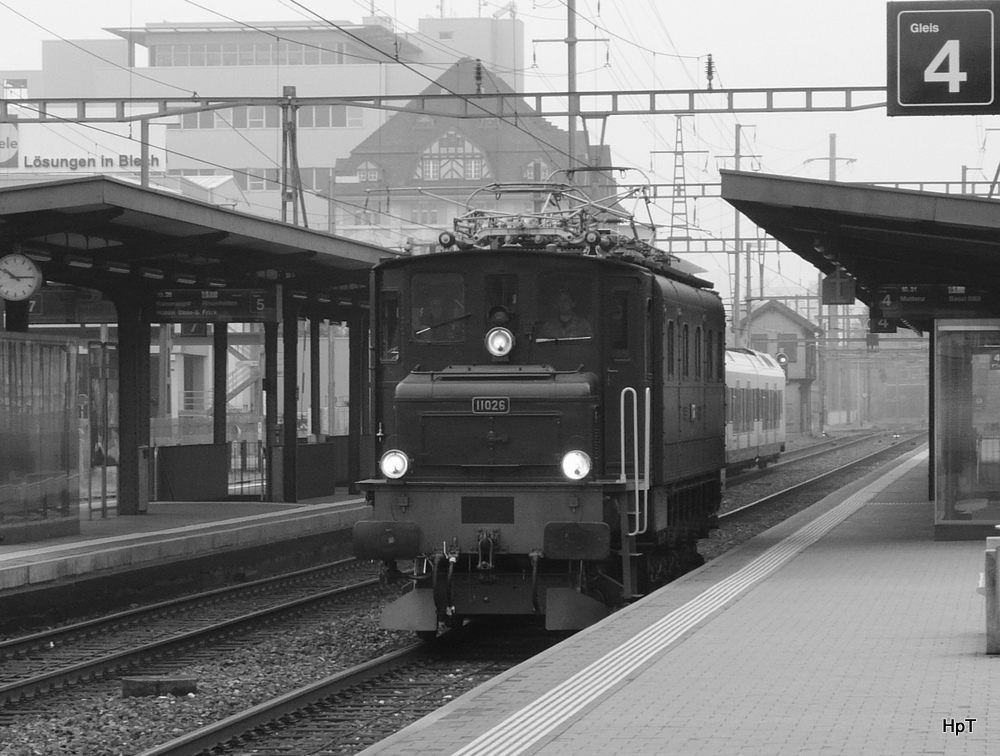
[603,276,650,476]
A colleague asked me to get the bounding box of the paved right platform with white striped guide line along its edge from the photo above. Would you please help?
[363,446,1000,756]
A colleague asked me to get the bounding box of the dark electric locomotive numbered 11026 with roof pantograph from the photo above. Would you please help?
[353,176,725,635]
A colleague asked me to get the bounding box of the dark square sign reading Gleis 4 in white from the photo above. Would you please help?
[886,0,1000,116]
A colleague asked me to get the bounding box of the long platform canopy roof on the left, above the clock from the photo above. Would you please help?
[0,176,396,307]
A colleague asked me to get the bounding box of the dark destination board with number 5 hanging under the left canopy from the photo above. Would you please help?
[149,289,278,323]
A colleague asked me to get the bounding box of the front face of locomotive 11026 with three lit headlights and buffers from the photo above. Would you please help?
[354,250,649,632]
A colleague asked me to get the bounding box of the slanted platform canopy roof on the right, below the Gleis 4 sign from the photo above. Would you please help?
[721,171,1000,328]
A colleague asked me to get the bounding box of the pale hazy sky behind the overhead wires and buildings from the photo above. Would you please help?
[0,0,1000,302]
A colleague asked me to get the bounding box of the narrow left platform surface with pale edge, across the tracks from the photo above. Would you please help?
[0,494,369,591]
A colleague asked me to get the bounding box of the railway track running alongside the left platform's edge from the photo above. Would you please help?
[0,560,379,721]
